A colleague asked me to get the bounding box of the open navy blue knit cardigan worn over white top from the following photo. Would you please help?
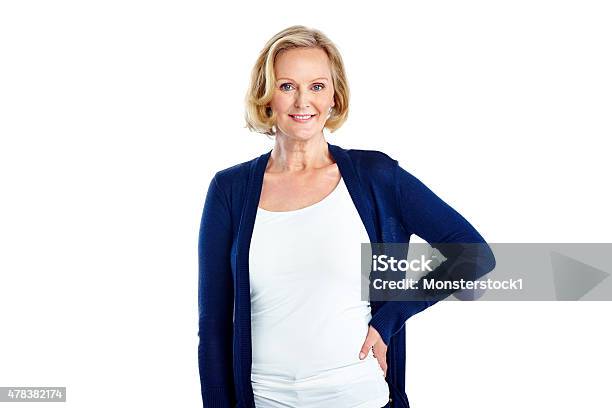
[198,143,495,408]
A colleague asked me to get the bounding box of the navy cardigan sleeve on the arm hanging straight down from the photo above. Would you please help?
[198,175,236,408]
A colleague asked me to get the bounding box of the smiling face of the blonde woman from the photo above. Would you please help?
[270,48,334,140]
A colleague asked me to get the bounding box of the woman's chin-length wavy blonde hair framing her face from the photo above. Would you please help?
[245,25,350,135]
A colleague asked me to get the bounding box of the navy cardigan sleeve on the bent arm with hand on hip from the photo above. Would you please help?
[369,161,495,345]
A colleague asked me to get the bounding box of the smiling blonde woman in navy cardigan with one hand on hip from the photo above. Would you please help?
[198,26,494,408]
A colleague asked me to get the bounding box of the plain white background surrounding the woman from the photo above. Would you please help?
[0,0,612,408]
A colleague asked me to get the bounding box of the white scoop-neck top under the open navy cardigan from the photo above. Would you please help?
[249,179,389,408]
